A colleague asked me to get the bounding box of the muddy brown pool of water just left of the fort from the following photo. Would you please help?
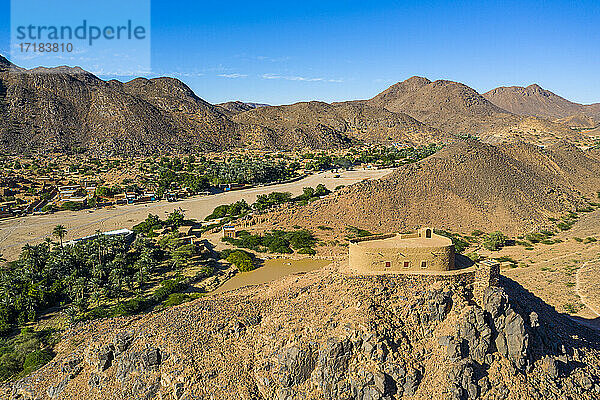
[213,258,331,293]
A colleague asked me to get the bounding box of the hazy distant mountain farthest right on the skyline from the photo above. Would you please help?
[483,84,600,123]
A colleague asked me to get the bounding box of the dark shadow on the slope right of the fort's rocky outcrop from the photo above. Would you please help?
[500,275,600,350]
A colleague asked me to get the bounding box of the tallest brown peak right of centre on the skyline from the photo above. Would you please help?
[365,76,519,135]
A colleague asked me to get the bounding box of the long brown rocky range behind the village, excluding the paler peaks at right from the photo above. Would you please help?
[0,57,448,155]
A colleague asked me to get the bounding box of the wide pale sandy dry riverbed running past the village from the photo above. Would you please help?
[0,169,390,260]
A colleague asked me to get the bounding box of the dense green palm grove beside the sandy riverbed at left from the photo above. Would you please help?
[0,211,209,381]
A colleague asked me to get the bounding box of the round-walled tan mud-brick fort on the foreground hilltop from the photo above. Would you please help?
[349,228,455,274]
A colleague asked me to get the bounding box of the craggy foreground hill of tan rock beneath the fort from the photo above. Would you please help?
[0,268,600,400]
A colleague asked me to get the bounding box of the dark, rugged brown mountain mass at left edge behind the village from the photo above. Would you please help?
[0,61,241,154]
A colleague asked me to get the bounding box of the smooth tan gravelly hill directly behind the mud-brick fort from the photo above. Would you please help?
[272,140,600,234]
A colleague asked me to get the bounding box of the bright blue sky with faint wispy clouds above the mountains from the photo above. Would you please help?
[0,0,600,104]
